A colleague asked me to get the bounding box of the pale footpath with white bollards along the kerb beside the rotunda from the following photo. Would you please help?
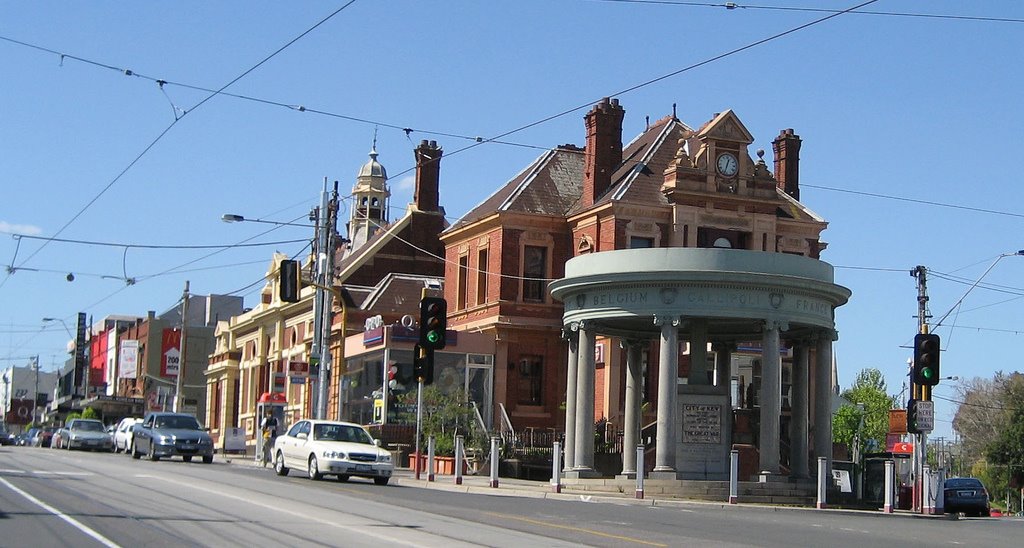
[222,455,958,519]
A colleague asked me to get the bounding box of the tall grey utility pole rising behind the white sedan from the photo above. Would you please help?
[310,177,344,419]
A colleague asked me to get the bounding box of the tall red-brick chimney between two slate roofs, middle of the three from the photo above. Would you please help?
[582,97,626,207]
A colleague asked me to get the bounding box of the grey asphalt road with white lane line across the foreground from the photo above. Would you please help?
[0,447,1024,547]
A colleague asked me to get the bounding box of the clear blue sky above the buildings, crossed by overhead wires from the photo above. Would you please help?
[0,0,1024,436]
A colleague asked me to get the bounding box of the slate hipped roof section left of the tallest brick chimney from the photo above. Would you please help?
[449,144,584,230]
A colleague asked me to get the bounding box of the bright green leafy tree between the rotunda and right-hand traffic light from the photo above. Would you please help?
[833,368,896,451]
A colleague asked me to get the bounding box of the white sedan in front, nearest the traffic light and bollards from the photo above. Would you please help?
[273,419,394,486]
